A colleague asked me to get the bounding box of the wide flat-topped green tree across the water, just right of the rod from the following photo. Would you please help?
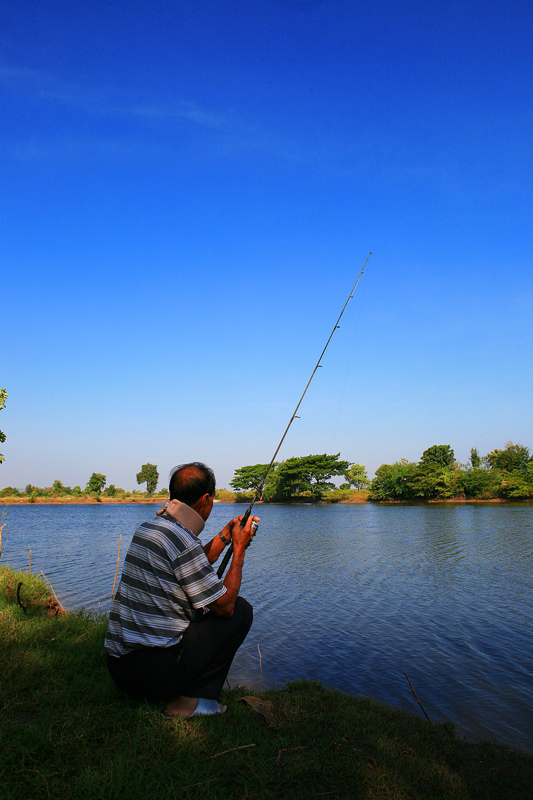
[264,453,350,500]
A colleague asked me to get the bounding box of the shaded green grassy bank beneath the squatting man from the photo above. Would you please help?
[0,568,533,800]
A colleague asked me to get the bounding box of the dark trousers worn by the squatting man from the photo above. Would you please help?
[107,597,253,701]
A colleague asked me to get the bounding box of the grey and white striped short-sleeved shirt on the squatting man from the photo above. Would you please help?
[105,515,226,657]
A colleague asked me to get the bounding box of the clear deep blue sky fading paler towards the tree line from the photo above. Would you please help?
[0,0,533,489]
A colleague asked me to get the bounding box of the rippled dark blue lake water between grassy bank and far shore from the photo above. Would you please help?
[2,504,533,751]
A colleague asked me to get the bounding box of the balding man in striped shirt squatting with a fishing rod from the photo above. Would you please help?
[105,462,259,717]
